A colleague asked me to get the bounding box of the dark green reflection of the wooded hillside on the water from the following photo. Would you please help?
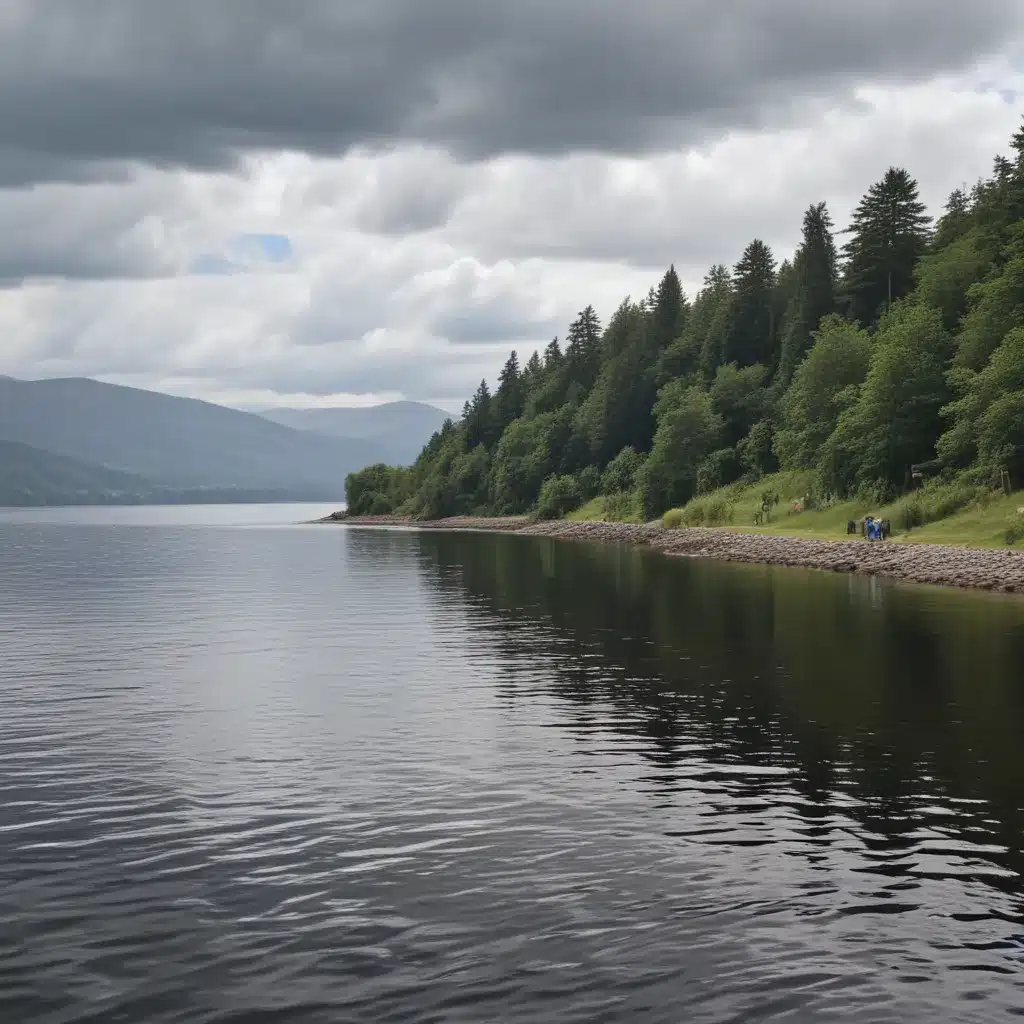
[411,534,1024,884]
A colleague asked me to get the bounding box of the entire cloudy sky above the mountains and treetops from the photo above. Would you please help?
[0,0,1024,410]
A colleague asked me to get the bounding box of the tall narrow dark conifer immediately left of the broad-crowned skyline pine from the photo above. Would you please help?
[778,203,837,386]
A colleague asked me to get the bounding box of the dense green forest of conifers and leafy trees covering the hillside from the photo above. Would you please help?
[346,118,1024,518]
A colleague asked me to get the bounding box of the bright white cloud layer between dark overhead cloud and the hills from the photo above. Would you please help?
[0,59,1024,411]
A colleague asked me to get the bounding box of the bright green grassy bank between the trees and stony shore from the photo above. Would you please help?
[659,473,1024,548]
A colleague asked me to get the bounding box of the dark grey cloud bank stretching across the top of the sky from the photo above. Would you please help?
[0,0,1024,184]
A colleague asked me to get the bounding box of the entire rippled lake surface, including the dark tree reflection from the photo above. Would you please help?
[0,507,1024,1024]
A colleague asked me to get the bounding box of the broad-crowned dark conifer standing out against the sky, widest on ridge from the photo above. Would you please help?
[843,167,931,327]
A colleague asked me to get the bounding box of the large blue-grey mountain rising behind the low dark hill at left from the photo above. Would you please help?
[0,378,385,501]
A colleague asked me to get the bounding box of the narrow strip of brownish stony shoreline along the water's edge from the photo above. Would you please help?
[315,512,1024,594]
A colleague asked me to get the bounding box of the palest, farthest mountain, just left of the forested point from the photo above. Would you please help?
[260,401,451,466]
